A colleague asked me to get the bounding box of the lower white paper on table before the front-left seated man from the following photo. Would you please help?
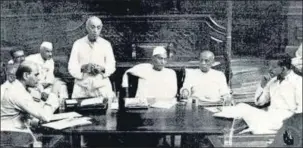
[42,117,92,130]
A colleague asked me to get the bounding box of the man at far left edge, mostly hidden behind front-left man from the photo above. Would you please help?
[1,64,19,100]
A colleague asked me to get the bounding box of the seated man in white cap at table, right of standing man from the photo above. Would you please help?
[122,46,177,99]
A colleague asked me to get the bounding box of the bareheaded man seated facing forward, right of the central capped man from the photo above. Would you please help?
[180,50,230,102]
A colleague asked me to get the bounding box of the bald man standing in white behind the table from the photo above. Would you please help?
[68,16,116,98]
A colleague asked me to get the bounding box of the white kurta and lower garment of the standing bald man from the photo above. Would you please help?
[68,36,116,98]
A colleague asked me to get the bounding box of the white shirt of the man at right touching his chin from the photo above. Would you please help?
[256,71,302,113]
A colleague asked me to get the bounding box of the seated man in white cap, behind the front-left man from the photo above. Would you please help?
[25,41,68,102]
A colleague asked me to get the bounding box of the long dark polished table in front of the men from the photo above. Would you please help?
[42,103,232,147]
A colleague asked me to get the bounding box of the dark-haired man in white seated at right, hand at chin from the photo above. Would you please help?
[236,55,302,134]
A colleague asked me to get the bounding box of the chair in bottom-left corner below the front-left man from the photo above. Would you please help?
[1,131,34,147]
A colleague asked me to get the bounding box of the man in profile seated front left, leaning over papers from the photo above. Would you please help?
[1,61,59,131]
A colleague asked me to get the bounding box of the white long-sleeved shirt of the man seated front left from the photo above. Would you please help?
[1,80,59,129]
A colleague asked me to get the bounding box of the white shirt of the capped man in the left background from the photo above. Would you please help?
[25,53,55,84]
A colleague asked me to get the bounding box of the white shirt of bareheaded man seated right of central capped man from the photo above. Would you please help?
[181,69,230,101]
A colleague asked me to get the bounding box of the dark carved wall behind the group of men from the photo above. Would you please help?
[1,0,302,75]
